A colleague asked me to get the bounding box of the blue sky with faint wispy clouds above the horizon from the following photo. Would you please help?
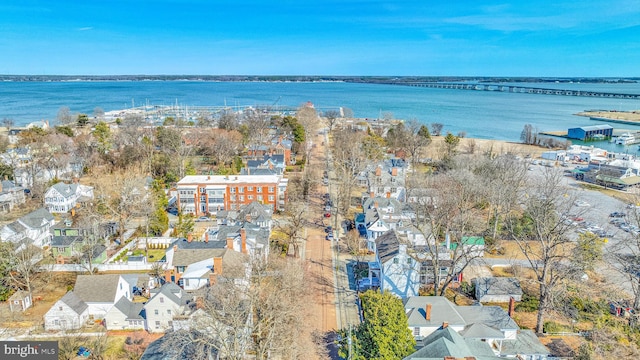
[0,0,640,77]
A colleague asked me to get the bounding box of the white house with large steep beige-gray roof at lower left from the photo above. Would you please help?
[73,274,136,319]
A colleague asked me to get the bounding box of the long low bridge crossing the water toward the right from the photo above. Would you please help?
[382,82,640,100]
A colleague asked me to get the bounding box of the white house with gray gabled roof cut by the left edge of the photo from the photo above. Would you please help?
[0,208,55,248]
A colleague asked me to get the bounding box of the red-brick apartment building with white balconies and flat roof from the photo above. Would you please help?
[176,175,288,216]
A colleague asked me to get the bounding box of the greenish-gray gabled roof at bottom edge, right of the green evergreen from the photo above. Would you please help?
[405,326,498,360]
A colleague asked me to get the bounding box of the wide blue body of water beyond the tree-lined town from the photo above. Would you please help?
[0,81,640,146]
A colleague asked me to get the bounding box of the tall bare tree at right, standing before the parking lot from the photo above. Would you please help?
[505,168,575,333]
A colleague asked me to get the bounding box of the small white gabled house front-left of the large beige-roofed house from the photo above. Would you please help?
[44,291,89,331]
